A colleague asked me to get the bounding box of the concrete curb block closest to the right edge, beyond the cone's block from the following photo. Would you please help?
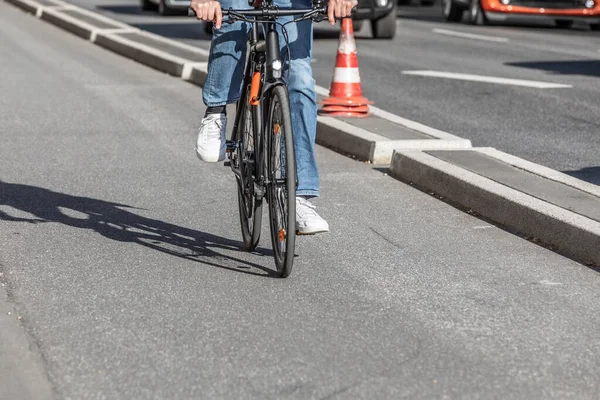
[390,149,600,266]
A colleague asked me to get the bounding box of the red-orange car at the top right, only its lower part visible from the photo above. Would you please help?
[442,0,600,30]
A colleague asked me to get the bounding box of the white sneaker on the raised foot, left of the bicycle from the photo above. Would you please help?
[196,114,227,162]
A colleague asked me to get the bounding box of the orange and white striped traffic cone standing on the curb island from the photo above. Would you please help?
[319,18,373,117]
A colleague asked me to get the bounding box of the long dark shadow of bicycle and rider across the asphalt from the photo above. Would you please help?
[0,180,277,278]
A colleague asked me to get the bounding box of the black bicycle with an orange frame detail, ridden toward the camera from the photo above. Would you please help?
[188,0,327,278]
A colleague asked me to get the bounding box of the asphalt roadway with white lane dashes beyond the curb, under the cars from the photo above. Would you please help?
[56,0,600,183]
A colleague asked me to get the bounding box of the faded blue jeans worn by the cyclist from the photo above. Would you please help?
[203,0,320,197]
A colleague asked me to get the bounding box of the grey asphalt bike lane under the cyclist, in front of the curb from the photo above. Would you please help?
[0,3,600,400]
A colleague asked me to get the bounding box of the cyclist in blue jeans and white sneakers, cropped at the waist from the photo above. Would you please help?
[190,0,357,234]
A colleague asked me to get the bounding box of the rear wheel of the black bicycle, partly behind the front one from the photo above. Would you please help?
[235,90,262,251]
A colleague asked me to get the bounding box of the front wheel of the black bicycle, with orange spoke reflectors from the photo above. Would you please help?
[265,86,296,278]
